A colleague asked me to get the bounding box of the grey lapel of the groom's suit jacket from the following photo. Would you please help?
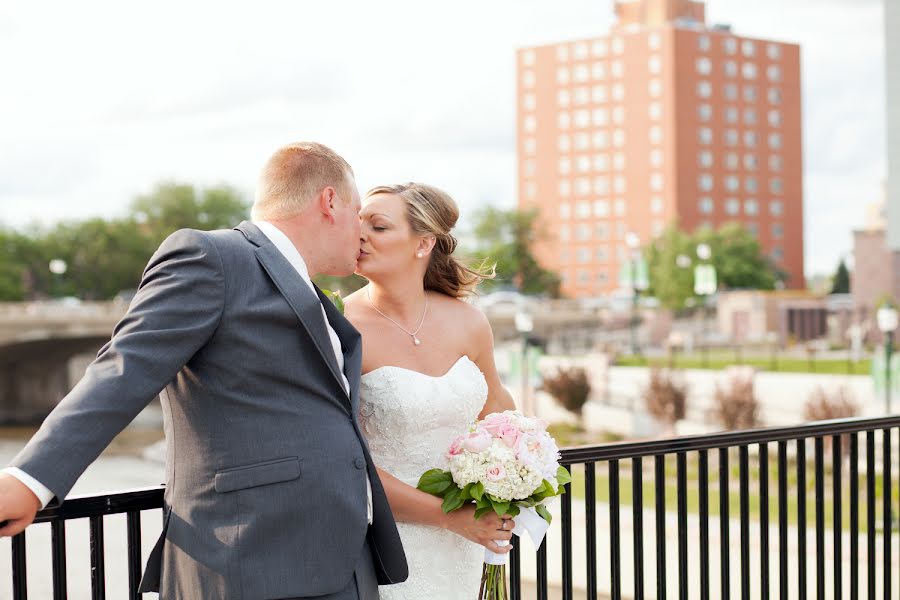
[237,221,349,408]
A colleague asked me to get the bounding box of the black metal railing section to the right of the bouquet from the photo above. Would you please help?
[510,417,900,600]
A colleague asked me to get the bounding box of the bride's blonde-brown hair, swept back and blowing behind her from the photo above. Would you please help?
[366,183,494,298]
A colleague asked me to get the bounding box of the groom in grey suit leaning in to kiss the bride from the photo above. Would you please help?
[0,143,407,600]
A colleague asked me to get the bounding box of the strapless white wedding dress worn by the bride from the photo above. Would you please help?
[360,356,487,600]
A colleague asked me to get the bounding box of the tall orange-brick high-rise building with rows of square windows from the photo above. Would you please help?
[517,0,805,297]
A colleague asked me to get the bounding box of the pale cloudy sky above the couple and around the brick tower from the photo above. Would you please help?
[0,0,887,275]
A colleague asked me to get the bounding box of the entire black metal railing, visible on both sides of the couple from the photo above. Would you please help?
[10,416,900,600]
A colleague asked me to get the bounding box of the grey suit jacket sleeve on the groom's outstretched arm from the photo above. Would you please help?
[10,229,225,505]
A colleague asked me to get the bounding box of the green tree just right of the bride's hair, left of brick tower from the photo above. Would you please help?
[472,207,559,297]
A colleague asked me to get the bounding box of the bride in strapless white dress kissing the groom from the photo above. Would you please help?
[346,183,515,600]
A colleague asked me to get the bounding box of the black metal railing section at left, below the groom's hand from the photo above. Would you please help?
[7,487,163,600]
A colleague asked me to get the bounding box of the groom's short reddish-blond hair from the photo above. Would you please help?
[251,142,353,220]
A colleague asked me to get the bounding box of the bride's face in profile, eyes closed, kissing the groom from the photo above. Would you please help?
[356,194,421,279]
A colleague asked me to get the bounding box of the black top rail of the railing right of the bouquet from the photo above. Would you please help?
[561,415,900,464]
